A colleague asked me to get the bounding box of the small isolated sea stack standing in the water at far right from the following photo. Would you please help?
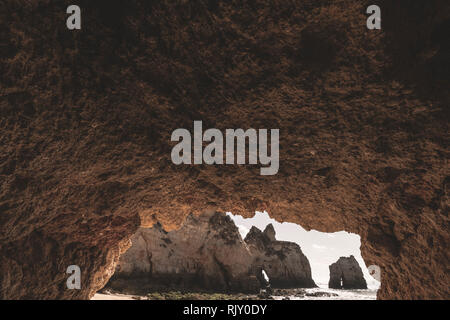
[328,256,367,289]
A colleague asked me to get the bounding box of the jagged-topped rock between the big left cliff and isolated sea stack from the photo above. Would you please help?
[245,224,316,288]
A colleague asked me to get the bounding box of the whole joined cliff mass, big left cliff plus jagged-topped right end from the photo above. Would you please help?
[108,212,315,293]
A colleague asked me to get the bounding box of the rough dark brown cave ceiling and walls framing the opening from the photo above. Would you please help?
[0,0,450,299]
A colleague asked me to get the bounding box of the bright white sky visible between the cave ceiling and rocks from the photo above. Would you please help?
[228,212,379,289]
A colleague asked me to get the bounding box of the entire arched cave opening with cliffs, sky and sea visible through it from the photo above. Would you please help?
[94,211,380,300]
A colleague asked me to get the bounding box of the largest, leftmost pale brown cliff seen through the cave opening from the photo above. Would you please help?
[108,212,260,293]
